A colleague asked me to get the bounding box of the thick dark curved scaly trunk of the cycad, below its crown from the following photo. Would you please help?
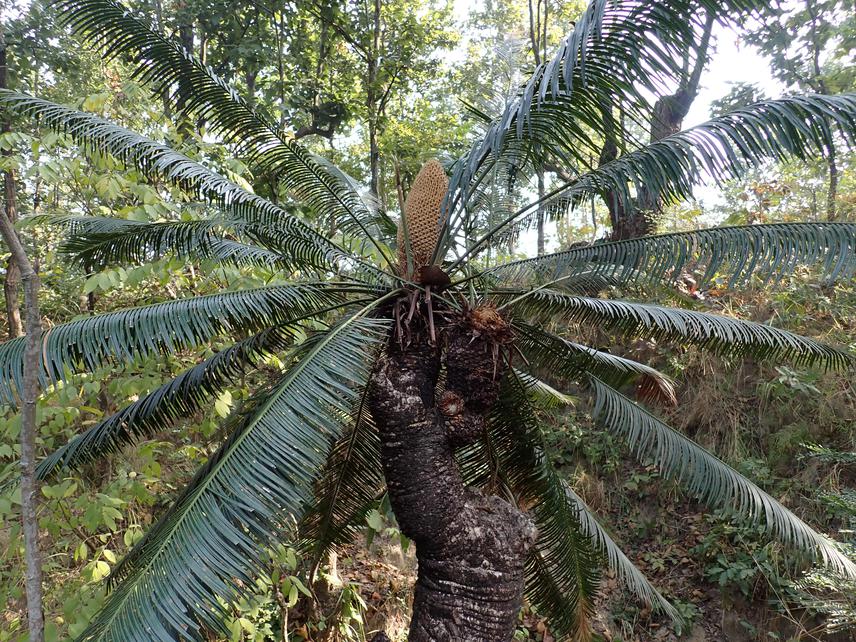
[371,323,536,642]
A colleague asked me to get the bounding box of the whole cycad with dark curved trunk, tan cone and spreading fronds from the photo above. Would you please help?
[0,0,856,642]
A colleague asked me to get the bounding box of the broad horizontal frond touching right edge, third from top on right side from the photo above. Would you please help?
[486,223,856,287]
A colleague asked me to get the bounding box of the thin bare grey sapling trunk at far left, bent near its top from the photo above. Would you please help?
[0,151,45,642]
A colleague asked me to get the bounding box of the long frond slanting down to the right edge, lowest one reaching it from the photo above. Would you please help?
[590,376,856,577]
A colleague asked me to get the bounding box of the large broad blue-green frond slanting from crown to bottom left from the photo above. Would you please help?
[79,310,389,642]
